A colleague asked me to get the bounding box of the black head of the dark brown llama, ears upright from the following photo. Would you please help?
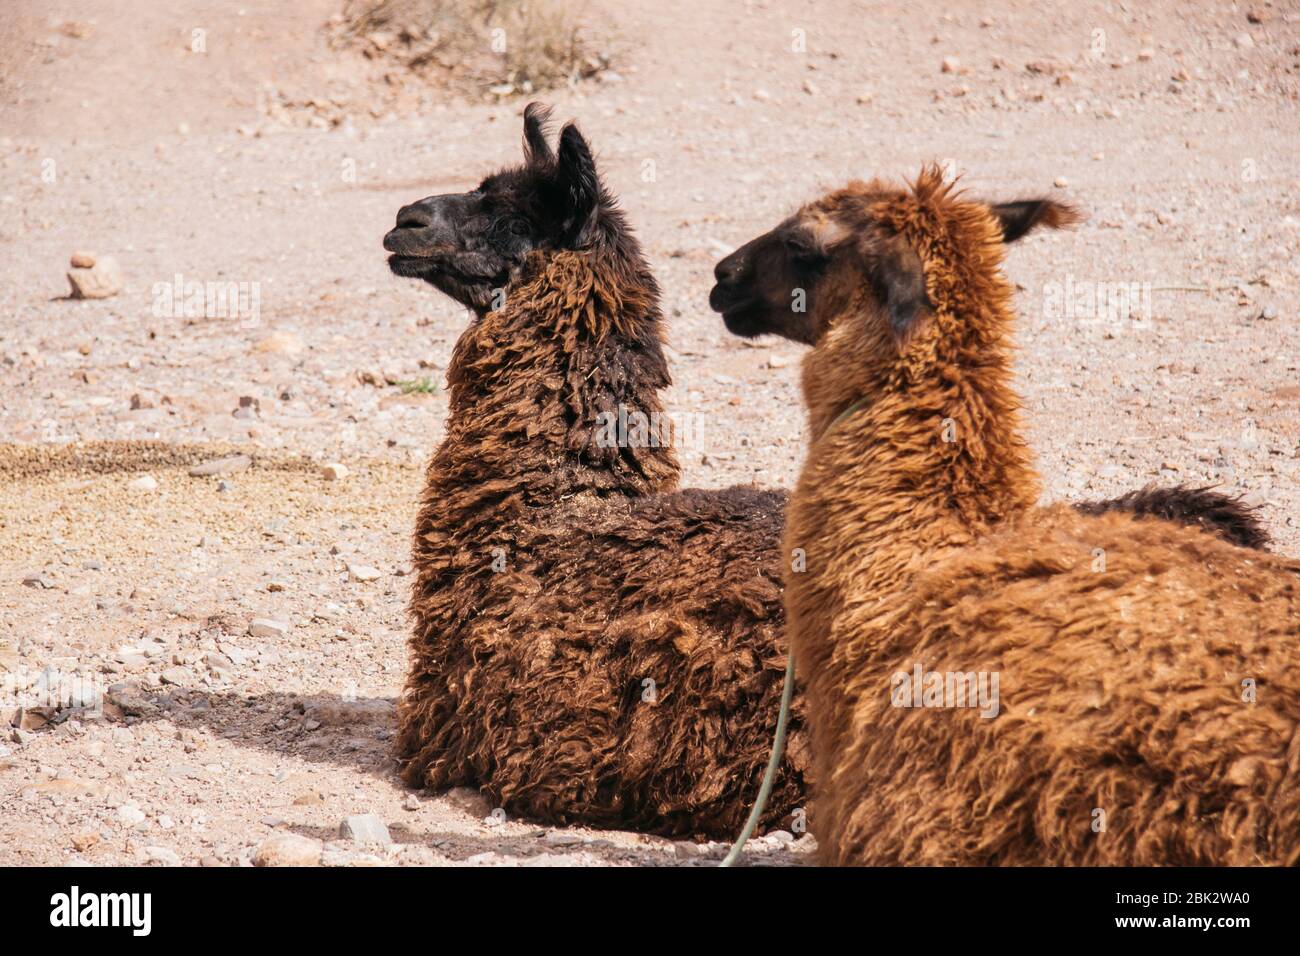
[384,103,636,315]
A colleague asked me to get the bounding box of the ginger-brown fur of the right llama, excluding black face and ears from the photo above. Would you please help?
[785,169,1300,865]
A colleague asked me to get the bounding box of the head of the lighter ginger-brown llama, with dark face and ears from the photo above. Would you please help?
[709,168,1078,362]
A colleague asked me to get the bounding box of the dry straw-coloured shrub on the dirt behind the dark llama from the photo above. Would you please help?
[330,0,608,96]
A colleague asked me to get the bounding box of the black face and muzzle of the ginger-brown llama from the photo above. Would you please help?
[709,220,827,345]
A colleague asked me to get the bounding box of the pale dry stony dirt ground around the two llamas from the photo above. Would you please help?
[0,0,1300,865]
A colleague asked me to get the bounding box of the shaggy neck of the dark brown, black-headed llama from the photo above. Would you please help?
[429,252,679,520]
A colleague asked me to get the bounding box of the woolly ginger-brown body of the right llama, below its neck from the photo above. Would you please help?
[819,507,1300,865]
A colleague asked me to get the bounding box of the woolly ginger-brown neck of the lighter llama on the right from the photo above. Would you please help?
[785,303,1039,671]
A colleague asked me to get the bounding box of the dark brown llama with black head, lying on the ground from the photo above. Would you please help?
[384,105,1263,838]
